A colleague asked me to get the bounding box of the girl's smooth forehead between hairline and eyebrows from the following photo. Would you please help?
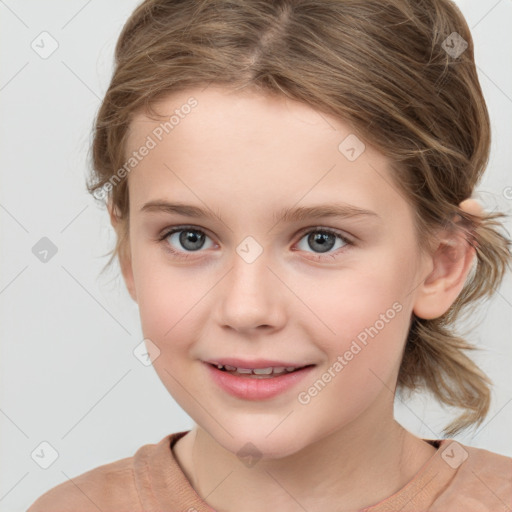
[126,86,406,220]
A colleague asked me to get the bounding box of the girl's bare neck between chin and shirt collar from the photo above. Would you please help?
[174,402,436,512]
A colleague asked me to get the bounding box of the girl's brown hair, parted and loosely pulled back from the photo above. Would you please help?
[88,0,512,435]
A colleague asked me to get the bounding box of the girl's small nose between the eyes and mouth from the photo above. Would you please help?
[215,246,292,332]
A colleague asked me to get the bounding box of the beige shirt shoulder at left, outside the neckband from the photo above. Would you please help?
[27,454,145,512]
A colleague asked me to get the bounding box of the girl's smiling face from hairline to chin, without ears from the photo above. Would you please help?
[119,87,432,457]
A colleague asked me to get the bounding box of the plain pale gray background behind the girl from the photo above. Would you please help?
[0,0,512,511]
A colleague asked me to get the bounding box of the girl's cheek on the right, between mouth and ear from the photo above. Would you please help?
[294,253,411,388]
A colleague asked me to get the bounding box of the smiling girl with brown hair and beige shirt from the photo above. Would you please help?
[29,0,512,512]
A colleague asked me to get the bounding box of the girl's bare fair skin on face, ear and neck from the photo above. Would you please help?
[110,86,478,512]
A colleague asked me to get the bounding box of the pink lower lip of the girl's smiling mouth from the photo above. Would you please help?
[204,363,314,400]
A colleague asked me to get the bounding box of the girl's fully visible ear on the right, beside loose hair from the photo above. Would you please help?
[413,221,475,320]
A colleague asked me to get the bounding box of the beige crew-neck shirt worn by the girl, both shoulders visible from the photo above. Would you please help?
[27,431,512,512]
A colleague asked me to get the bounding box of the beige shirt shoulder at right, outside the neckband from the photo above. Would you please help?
[429,440,512,512]
